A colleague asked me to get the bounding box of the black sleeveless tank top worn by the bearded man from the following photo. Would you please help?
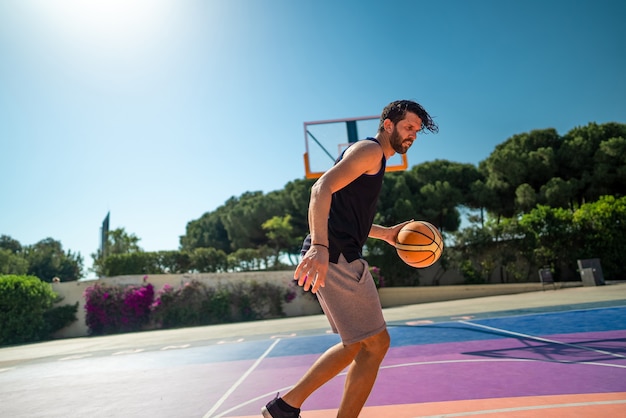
[302,138,387,263]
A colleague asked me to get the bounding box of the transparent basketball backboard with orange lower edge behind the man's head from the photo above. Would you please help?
[304,116,409,179]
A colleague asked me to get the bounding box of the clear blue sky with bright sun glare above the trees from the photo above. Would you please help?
[0,0,626,278]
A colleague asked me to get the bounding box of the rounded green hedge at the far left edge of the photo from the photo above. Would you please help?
[0,275,78,345]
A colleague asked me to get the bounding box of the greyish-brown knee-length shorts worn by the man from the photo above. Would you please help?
[317,255,386,345]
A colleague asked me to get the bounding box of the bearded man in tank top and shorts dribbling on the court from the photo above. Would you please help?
[262,100,438,418]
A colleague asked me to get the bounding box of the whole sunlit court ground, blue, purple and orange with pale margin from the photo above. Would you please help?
[0,283,626,418]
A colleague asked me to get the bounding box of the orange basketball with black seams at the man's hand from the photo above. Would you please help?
[396,221,443,268]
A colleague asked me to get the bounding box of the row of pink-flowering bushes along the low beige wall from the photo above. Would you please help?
[85,276,296,335]
